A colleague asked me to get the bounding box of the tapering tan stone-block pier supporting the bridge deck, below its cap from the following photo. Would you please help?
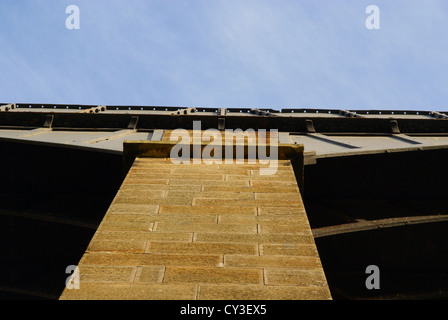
[60,158,331,300]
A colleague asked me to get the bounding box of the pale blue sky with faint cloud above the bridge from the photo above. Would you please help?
[0,0,448,111]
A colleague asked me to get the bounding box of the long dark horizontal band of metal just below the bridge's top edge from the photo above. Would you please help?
[0,112,448,135]
